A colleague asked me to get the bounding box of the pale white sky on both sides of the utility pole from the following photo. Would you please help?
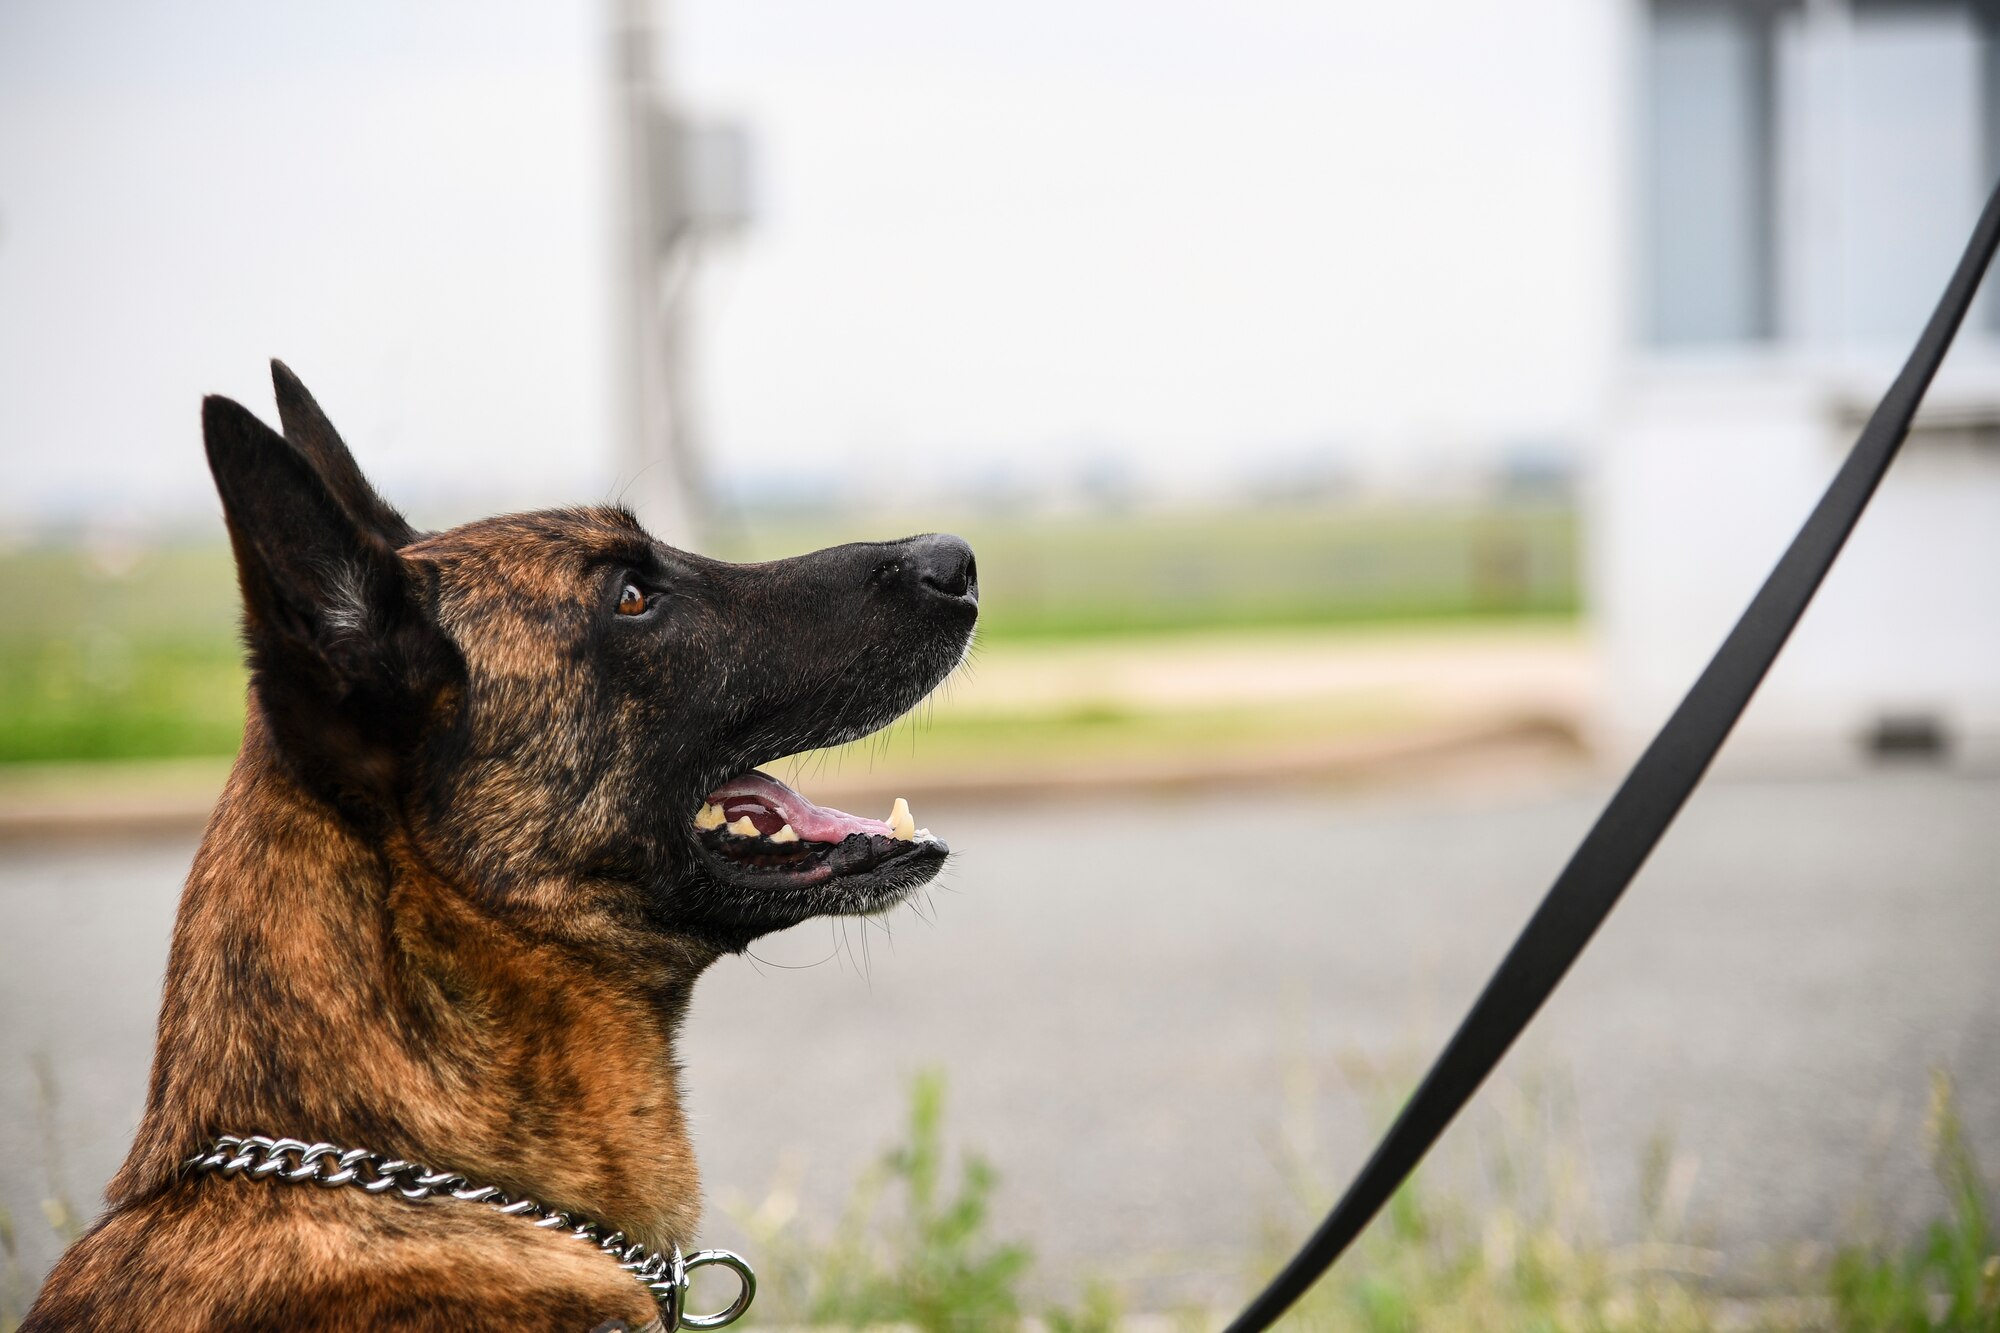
[0,0,1622,518]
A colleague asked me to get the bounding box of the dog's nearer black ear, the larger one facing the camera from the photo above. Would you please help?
[202,398,458,797]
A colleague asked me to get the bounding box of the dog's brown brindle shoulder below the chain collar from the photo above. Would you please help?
[22,1181,658,1333]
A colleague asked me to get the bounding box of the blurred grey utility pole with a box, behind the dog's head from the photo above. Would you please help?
[606,0,750,548]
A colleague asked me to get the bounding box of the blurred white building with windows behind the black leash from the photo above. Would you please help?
[1588,0,2000,765]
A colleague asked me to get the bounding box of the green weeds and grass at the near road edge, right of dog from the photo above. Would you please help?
[738,1071,2000,1333]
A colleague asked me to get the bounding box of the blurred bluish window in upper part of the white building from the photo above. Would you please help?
[1640,0,2000,348]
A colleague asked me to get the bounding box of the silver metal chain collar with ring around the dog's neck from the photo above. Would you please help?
[182,1135,756,1333]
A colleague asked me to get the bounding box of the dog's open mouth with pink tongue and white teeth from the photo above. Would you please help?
[694,771,950,911]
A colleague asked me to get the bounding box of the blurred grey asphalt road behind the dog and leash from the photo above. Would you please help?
[0,773,2000,1307]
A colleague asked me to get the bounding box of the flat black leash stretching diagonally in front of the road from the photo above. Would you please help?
[1226,171,2000,1333]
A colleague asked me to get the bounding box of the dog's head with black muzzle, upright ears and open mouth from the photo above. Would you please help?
[204,364,978,949]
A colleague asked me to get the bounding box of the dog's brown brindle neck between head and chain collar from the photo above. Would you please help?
[108,711,708,1247]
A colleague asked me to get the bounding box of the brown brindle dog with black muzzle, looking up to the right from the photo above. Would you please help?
[24,362,978,1333]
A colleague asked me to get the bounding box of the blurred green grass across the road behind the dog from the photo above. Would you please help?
[0,506,1578,763]
